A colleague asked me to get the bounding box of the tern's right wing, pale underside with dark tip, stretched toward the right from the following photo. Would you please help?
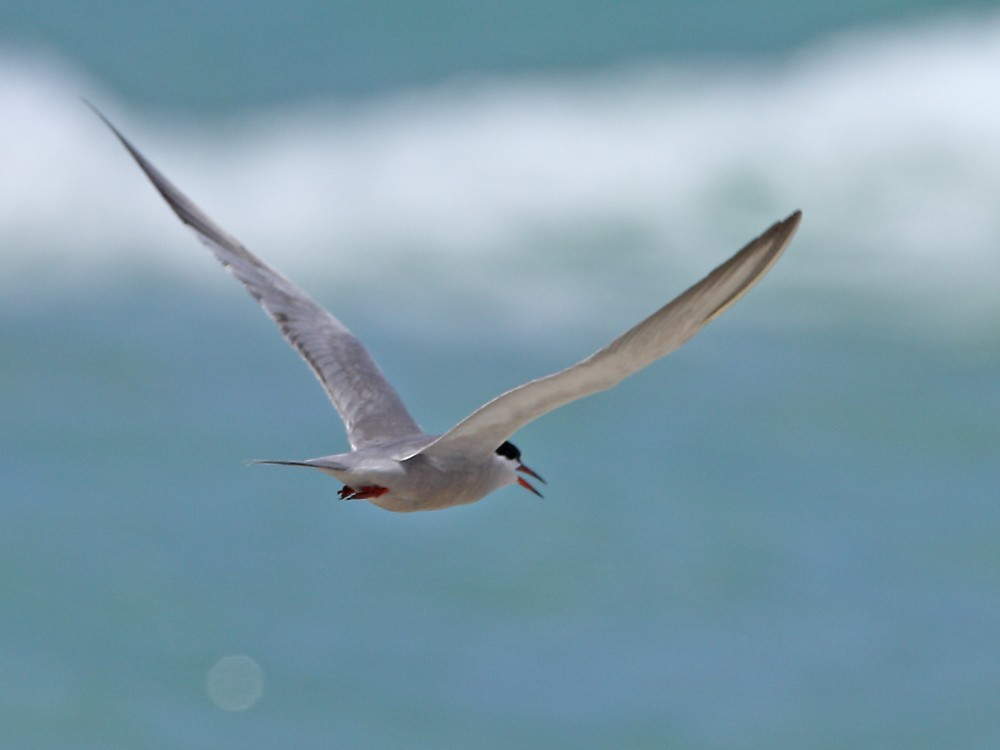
[410,211,802,464]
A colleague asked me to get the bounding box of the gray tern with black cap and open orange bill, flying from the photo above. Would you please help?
[86,102,802,512]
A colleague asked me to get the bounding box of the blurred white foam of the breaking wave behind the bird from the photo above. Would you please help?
[0,13,1000,338]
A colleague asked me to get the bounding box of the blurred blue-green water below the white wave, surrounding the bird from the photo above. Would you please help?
[2,285,1000,748]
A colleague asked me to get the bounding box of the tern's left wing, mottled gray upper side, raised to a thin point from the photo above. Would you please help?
[91,105,420,448]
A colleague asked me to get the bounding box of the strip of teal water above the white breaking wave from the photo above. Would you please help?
[0,0,997,113]
